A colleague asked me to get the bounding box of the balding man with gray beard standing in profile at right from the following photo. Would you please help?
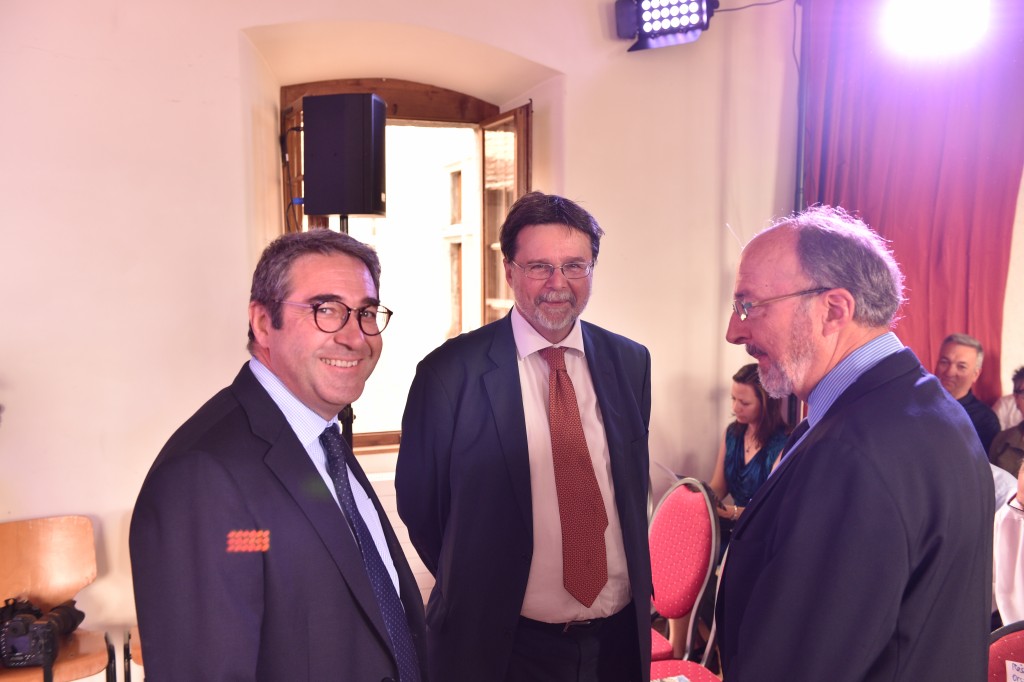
[717,207,993,682]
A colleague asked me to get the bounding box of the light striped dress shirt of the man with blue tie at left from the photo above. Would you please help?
[249,357,401,594]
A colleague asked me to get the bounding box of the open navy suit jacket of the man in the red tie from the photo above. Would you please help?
[395,316,651,682]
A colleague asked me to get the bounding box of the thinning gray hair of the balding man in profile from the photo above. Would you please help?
[768,206,904,328]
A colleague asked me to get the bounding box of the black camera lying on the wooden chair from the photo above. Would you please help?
[0,599,85,669]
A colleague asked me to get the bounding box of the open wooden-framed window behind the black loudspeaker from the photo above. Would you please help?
[281,79,529,449]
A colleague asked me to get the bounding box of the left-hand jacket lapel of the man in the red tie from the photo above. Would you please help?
[481,315,534,532]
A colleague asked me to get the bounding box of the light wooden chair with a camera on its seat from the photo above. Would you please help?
[0,516,116,682]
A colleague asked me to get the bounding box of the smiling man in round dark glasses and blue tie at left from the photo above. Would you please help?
[130,229,426,682]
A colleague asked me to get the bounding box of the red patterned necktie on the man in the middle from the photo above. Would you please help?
[540,346,608,606]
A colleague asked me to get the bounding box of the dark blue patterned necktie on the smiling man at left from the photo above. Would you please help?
[321,424,420,682]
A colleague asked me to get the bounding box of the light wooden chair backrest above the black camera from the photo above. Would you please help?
[0,516,96,611]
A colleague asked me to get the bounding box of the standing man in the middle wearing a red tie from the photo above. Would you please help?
[395,193,651,682]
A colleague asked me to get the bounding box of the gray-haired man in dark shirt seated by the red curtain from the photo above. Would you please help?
[935,334,999,453]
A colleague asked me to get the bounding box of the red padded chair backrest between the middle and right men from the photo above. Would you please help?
[647,478,719,619]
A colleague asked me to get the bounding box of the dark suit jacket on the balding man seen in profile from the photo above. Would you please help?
[718,349,993,682]
